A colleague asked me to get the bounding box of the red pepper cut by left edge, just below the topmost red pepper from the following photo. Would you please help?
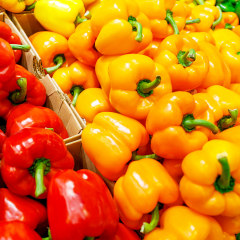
[0,38,15,88]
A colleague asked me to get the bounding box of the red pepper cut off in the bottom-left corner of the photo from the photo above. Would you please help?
[0,221,42,240]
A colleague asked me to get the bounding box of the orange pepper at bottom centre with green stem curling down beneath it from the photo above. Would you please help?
[114,158,178,230]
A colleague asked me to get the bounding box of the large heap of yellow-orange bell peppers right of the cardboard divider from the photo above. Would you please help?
[4,0,240,240]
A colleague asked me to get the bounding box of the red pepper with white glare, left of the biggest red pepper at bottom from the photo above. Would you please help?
[0,188,47,229]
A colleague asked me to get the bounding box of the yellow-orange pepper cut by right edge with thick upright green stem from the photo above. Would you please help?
[180,139,240,217]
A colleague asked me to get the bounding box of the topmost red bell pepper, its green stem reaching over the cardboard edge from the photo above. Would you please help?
[0,21,30,63]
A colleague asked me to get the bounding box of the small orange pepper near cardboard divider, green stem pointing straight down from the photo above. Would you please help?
[53,61,99,107]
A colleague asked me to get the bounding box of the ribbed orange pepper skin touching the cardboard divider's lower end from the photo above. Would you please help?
[82,112,149,180]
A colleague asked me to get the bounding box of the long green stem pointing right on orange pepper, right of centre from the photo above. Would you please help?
[182,114,219,134]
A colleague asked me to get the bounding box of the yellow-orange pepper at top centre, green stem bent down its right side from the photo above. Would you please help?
[91,0,152,55]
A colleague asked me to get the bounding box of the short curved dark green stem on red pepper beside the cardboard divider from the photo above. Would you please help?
[9,78,27,104]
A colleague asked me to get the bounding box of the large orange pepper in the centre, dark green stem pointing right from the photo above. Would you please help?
[108,54,172,119]
